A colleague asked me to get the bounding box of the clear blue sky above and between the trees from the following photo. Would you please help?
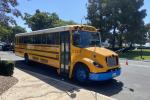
[16,0,150,31]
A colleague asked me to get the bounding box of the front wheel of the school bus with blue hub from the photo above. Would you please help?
[74,64,89,84]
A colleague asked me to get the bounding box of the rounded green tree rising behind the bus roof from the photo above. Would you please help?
[24,10,75,31]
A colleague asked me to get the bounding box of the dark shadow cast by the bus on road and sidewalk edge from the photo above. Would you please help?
[15,61,124,98]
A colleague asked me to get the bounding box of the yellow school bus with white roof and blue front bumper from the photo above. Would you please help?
[15,25,121,83]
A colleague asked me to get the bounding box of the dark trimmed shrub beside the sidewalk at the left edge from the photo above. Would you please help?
[0,61,14,76]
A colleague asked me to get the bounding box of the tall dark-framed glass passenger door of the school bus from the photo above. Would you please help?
[60,32,70,76]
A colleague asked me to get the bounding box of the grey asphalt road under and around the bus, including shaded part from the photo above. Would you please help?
[0,52,150,100]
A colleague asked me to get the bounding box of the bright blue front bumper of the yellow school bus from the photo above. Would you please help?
[89,69,121,81]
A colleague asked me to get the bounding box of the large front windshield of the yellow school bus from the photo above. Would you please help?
[73,31,101,48]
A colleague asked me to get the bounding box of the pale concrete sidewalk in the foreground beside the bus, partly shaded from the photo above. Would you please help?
[0,68,114,100]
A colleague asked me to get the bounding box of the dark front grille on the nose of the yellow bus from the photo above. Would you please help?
[106,56,118,67]
